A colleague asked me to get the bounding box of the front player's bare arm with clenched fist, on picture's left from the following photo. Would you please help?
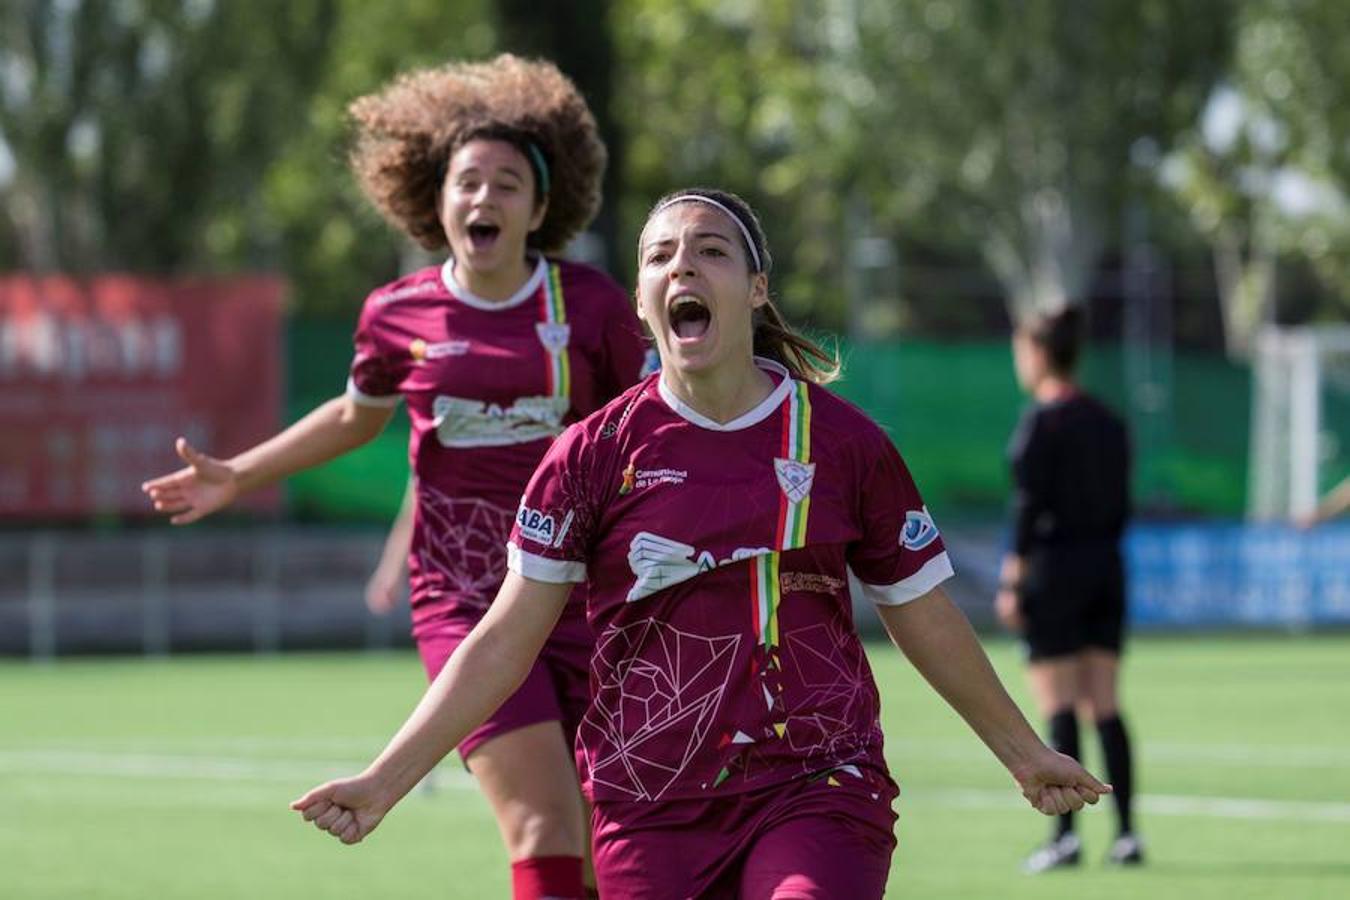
[290,571,572,843]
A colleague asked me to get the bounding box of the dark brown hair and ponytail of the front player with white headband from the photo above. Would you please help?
[647,188,841,385]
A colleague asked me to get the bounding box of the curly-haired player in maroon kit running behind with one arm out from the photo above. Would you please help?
[144,55,644,899]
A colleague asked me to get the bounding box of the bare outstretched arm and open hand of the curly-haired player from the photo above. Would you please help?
[140,395,393,525]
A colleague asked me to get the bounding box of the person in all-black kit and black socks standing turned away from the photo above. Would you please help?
[996,309,1143,872]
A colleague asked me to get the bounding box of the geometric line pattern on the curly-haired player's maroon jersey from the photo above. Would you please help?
[417,480,516,610]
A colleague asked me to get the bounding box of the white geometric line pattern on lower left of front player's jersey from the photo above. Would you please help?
[579,619,741,800]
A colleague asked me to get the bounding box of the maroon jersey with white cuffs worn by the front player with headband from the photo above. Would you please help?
[509,360,952,801]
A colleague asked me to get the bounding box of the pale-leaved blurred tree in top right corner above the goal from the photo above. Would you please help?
[1162,0,1350,358]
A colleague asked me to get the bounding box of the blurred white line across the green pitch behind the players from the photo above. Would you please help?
[0,750,1350,823]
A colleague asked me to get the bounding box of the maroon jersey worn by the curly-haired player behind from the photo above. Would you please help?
[347,259,644,633]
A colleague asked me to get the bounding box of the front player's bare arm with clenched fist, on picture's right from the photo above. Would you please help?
[876,588,1111,815]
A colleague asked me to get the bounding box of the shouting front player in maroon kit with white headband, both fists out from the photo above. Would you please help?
[293,190,1110,899]
